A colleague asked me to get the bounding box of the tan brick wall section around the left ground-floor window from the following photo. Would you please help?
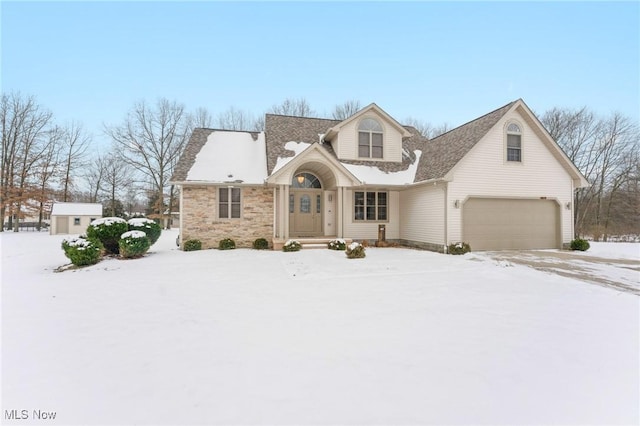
[180,186,274,249]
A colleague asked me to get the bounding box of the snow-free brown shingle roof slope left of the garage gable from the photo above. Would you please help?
[416,101,517,182]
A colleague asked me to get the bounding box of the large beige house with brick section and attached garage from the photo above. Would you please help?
[172,100,588,251]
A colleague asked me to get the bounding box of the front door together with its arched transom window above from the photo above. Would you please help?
[289,172,323,237]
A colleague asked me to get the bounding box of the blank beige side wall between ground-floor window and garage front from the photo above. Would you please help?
[400,184,445,245]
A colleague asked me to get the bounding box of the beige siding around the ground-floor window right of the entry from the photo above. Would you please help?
[343,188,400,240]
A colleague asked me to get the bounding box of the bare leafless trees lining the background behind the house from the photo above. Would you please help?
[0,92,640,239]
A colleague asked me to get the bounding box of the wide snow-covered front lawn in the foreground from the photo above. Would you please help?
[0,231,640,425]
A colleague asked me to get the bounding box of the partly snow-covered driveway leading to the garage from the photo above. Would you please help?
[474,243,640,295]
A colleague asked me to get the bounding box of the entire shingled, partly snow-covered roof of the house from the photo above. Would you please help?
[171,99,588,187]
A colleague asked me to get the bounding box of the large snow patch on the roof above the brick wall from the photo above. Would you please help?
[187,130,267,183]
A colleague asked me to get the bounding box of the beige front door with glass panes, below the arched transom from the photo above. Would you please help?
[289,189,322,237]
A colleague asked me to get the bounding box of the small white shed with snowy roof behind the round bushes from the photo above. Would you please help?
[49,203,102,235]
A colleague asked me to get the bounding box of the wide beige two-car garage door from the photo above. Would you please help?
[462,198,560,250]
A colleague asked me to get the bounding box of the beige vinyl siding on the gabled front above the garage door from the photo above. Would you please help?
[447,112,573,243]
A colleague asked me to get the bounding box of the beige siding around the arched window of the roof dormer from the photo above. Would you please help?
[332,114,402,161]
